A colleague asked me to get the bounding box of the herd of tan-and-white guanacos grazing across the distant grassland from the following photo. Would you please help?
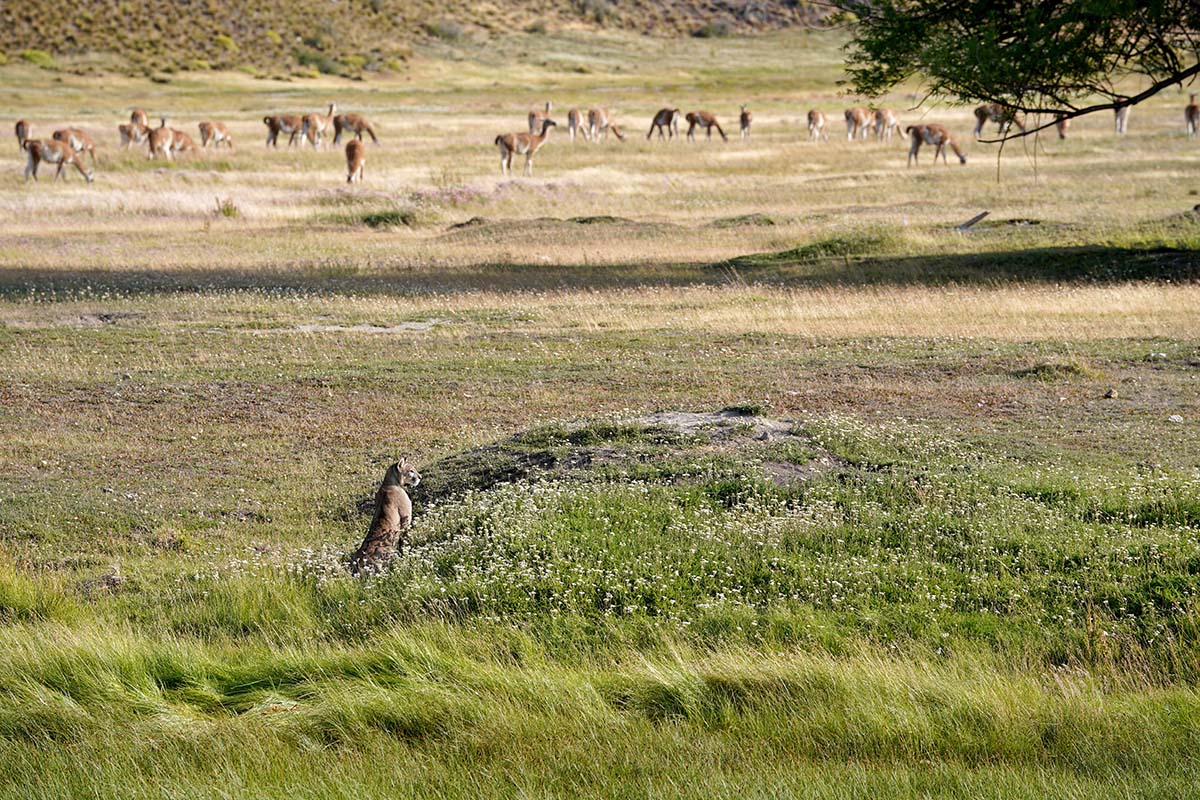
[16,94,1200,184]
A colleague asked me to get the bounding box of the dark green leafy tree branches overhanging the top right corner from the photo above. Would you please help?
[834,0,1200,120]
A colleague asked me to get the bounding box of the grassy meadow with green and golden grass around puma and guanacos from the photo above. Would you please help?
[0,31,1200,798]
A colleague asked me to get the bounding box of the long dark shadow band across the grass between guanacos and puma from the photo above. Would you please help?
[0,246,1200,300]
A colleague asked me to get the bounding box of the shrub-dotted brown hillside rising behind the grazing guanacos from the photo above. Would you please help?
[0,0,818,76]
